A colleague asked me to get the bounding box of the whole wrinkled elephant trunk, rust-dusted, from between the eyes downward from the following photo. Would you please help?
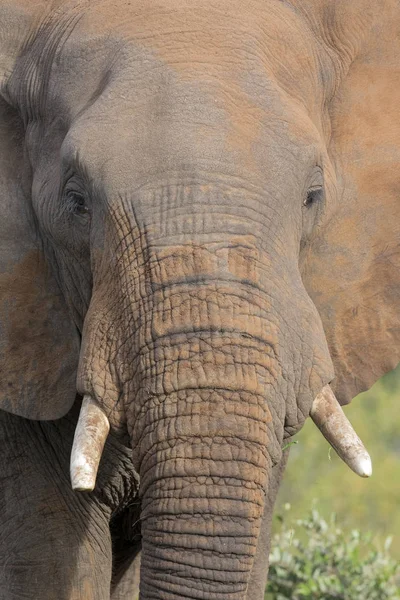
[80,185,332,600]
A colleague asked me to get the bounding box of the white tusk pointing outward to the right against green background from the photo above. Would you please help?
[310,385,372,477]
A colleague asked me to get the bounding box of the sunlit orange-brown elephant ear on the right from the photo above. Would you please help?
[303,2,400,404]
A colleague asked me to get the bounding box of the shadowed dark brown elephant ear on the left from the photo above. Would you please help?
[0,2,79,419]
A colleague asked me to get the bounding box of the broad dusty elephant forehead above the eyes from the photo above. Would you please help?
[19,0,322,188]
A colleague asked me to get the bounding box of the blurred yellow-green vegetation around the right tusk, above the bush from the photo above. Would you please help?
[275,358,400,561]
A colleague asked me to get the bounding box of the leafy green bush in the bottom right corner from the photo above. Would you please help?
[265,507,400,600]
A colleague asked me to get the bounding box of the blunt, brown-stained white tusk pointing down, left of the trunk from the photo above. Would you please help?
[70,396,110,492]
